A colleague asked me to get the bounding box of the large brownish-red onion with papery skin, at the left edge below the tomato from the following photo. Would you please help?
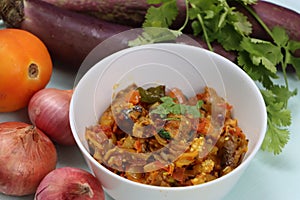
[0,122,57,196]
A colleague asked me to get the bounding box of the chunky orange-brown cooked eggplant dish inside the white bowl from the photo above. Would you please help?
[85,84,248,187]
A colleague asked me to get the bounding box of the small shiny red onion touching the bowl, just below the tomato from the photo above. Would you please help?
[28,88,75,145]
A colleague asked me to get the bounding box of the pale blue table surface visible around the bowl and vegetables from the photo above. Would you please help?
[0,0,300,200]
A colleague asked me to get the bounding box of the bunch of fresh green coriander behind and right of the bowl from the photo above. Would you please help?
[129,0,300,154]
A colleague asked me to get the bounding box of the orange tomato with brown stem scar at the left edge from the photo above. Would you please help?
[0,29,52,112]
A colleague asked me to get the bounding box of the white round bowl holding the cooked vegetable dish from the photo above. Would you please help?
[70,44,267,200]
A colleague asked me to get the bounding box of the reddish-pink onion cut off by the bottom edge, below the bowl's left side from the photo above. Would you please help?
[34,167,105,200]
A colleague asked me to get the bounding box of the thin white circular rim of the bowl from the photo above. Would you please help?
[69,43,267,191]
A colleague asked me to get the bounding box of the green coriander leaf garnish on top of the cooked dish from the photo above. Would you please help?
[150,96,203,118]
